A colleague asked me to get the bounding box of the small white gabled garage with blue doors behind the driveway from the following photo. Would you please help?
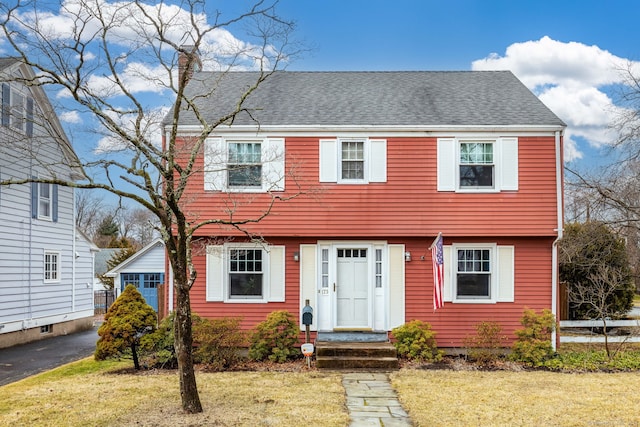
[105,239,165,311]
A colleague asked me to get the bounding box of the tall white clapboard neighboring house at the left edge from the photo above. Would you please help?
[0,58,96,348]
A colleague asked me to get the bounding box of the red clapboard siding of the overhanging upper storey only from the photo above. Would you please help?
[180,137,557,237]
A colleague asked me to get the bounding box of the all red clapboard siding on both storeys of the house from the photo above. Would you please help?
[168,135,558,347]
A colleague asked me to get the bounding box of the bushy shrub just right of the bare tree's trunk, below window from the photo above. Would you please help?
[193,317,246,371]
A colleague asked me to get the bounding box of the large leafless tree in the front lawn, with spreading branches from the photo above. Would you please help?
[0,0,300,413]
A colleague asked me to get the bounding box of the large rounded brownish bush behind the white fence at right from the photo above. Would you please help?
[559,221,635,319]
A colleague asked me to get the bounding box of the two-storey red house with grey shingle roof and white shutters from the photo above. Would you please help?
[166,71,565,347]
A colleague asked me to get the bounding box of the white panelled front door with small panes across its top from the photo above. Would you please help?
[335,247,371,329]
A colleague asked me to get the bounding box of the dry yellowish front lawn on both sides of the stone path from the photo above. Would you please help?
[0,359,640,427]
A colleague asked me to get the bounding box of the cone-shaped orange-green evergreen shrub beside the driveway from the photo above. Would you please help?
[94,285,158,369]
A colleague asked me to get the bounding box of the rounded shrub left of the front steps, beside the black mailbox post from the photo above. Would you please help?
[249,310,299,363]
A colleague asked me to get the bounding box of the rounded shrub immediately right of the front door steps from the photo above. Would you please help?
[391,320,442,362]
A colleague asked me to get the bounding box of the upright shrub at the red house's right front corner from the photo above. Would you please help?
[511,309,556,366]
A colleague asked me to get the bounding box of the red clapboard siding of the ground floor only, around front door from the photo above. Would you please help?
[184,238,552,347]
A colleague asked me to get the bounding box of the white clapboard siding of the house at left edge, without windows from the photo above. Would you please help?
[0,61,93,334]
